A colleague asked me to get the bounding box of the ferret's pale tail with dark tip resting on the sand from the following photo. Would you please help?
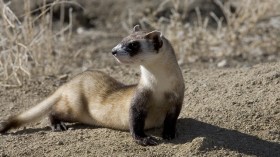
[0,90,61,133]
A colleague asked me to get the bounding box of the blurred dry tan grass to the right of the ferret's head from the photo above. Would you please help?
[144,0,280,63]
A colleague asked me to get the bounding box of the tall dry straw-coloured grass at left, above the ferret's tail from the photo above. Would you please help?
[0,0,71,87]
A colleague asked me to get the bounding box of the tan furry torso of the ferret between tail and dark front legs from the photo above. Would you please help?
[50,71,134,130]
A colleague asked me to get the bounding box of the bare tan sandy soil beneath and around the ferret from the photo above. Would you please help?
[0,1,280,157]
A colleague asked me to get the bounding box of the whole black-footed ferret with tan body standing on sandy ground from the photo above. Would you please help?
[0,25,185,145]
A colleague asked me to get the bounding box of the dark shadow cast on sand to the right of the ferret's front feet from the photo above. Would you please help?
[175,118,280,157]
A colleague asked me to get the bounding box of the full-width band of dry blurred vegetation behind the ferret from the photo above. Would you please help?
[0,0,280,87]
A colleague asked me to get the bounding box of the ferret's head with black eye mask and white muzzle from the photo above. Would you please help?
[112,25,163,65]
